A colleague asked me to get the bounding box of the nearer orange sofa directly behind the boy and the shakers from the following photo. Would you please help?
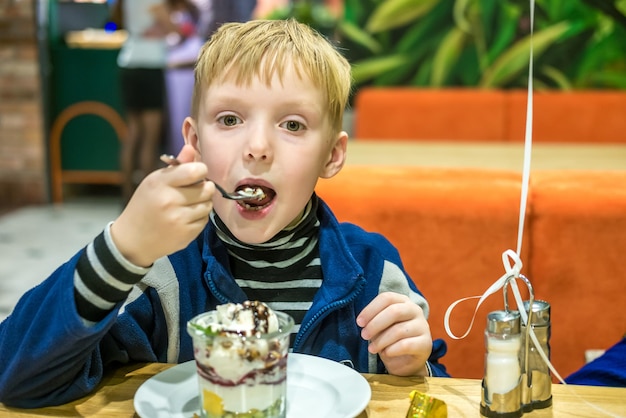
[317,166,626,378]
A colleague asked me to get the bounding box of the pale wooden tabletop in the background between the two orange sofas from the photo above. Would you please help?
[347,139,626,172]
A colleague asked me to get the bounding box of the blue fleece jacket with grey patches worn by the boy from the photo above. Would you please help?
[0,201,448,408]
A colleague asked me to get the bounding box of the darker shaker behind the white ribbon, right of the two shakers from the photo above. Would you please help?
[522,300,552,412]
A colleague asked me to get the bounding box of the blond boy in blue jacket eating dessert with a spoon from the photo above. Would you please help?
[0,20,446,407]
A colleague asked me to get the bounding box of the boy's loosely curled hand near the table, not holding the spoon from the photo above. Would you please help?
[356,292,433,376]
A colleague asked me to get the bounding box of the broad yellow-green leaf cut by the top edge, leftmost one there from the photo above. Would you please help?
[365,0,438,33]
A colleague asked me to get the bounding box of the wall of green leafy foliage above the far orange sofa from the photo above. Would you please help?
[338,0,626,89]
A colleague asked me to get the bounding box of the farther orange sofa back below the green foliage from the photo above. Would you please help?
[353,87,626,143]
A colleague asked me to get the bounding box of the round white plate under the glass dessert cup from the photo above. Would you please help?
[134,353,372,418]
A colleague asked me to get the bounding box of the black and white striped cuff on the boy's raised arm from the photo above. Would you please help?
[74,222,150,326]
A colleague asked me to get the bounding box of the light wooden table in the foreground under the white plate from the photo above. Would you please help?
[0,363,626,418]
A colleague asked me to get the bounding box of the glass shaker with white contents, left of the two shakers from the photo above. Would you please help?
[480,311,522,418]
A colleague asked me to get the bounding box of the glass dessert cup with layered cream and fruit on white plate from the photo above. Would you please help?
[187,311,294,418]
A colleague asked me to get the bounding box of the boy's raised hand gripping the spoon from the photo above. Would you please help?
[111,146,215,267]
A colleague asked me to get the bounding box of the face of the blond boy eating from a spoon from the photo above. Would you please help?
[183,65,348,243]
